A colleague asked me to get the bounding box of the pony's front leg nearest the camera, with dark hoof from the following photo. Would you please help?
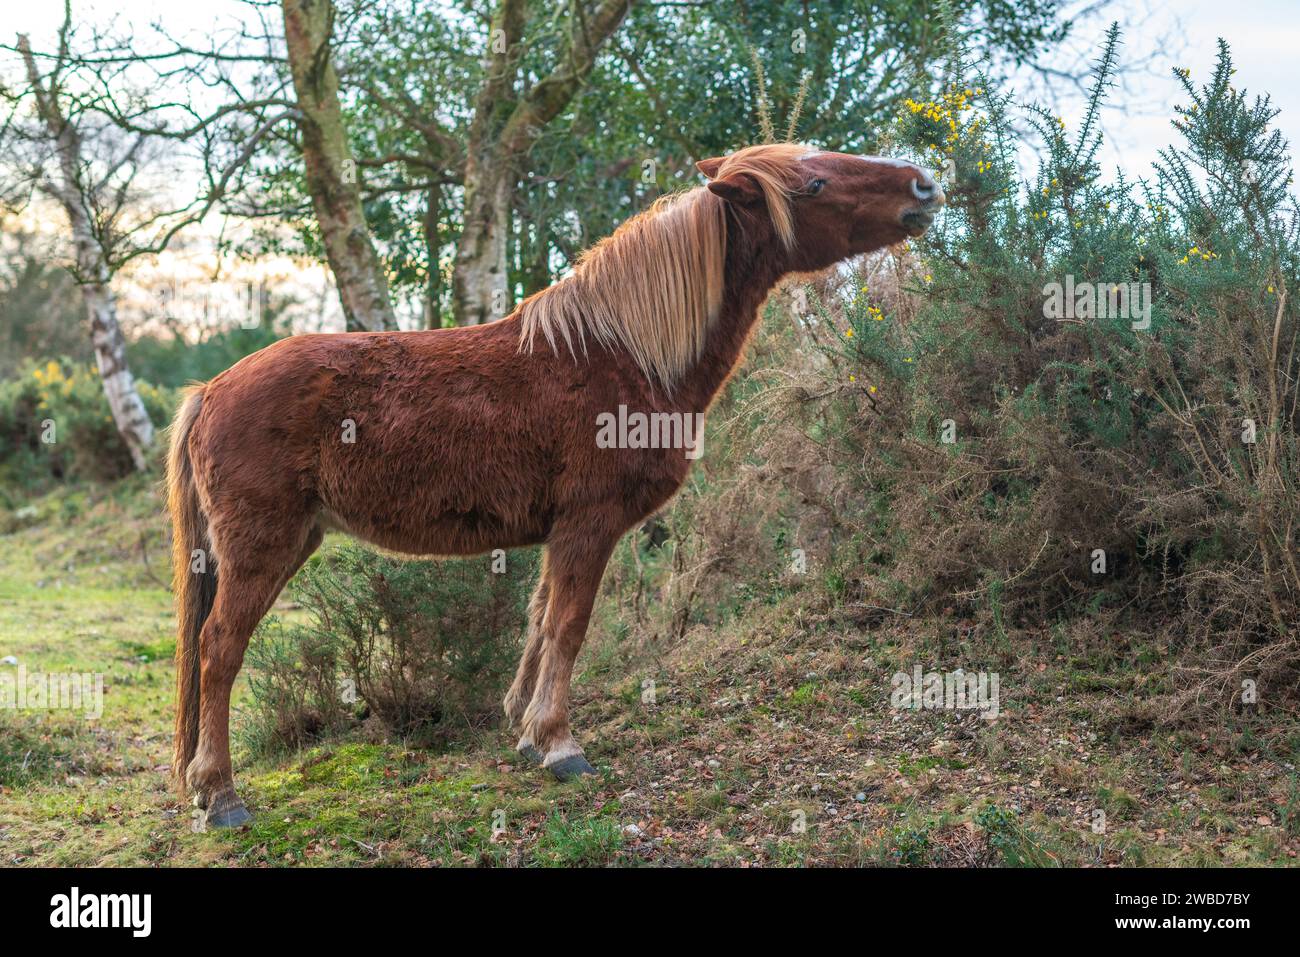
[524,528,614,780]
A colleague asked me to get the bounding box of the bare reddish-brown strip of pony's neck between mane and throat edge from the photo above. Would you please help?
[673,212,785,412]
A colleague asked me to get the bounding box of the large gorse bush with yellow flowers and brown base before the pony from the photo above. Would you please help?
[614,30,1300,720]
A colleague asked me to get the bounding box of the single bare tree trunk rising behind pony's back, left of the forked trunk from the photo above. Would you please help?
[282,0,398,332]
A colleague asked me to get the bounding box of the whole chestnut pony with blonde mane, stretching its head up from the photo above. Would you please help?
[168,144,944,827]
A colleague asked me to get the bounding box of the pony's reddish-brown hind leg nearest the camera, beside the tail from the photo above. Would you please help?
[186,525,322,827]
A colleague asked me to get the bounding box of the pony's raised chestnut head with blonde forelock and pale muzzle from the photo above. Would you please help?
[697,143,944,272]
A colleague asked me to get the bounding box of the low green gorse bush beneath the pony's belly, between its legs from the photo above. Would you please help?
[244,542,537,750]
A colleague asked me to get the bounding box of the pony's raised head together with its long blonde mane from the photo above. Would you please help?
[520,143,944,389]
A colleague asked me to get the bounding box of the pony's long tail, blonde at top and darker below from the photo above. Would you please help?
[166,385,217,800]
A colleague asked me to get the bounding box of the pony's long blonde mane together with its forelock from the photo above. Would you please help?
[520,143,809,390]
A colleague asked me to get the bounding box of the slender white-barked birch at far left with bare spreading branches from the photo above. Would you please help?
[0,0,293,471]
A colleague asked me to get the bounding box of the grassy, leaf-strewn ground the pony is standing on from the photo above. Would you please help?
[0,484,1300,867]
